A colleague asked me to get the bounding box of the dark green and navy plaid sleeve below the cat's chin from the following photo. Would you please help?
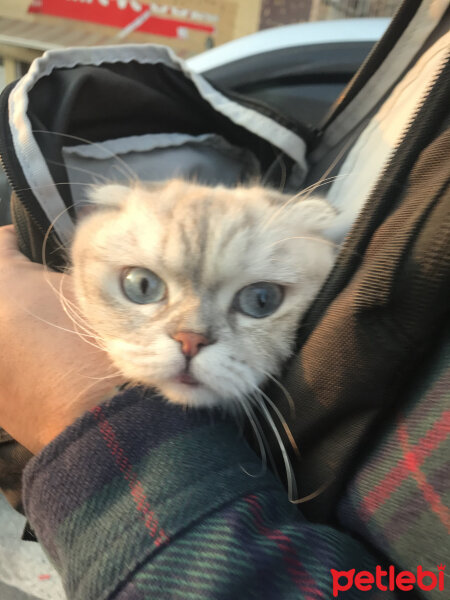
[24,391,398,600]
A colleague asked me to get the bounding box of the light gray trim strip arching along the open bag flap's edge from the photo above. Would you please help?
[9,44,307,244]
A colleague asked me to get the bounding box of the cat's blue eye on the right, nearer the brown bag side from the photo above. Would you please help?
[233,281,284,319]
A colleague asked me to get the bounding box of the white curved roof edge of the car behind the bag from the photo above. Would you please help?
[187,18,390,73]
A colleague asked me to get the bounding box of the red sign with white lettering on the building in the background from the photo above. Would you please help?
[28,0,218,38]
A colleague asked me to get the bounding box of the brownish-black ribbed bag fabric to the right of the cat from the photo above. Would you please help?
[268,58,450,522]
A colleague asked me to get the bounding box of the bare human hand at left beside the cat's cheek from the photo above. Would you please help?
[0,226,123,453]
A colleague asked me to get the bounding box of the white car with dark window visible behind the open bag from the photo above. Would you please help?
[187,18,390,128]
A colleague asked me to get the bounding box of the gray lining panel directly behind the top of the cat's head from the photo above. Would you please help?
[63,133,261,208]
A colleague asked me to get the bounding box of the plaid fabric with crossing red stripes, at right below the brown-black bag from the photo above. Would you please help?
[340,335,450,600]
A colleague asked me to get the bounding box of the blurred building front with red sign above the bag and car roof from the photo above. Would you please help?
[0,0,400,89]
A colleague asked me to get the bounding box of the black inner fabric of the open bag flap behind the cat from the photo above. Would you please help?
[28,61,298,213]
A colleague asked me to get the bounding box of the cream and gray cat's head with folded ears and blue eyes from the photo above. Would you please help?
[71,180,336,408]
